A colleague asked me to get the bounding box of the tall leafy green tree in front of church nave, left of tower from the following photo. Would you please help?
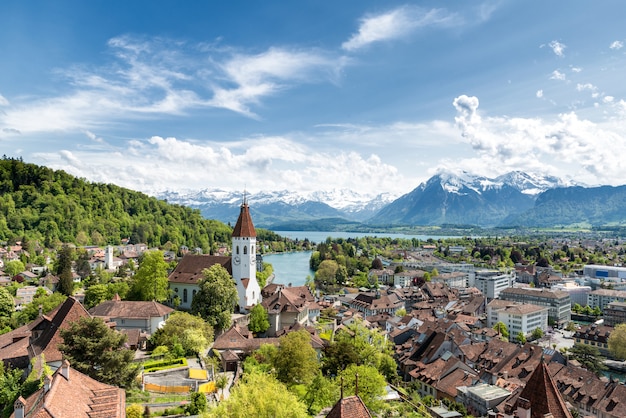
[191,264,238,330]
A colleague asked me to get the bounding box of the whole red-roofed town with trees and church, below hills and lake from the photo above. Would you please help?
[0,200,626,418]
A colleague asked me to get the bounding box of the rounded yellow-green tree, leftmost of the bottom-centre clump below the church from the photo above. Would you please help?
[273,330,319,386]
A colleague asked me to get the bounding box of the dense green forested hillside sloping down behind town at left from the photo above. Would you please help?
[0,156,231,248]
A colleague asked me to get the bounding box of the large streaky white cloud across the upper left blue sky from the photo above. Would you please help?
[0,36,348,136]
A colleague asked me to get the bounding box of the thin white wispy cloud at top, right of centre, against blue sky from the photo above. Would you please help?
[341,6,458,51]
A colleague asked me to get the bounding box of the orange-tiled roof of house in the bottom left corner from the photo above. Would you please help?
[11,360,126,418]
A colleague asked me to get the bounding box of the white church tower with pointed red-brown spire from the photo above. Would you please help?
[231,195,261,312]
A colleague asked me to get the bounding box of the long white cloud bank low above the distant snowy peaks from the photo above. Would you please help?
[34,136,406,197]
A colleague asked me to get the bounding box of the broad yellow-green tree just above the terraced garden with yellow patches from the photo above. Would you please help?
[150,312,213,355]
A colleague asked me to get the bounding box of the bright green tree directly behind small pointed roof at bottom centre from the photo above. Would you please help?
[337,364,387,412]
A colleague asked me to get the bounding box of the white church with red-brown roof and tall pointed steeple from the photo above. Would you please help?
[168,197,261,313]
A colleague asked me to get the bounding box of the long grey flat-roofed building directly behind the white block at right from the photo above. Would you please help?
[500,287,572,328]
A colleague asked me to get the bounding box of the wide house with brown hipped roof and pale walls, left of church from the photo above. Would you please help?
[89,295,174,334]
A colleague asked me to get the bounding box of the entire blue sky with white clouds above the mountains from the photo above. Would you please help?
[0,0,626,196]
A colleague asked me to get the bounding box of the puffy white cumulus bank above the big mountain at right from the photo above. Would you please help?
[442,96,626,184]
